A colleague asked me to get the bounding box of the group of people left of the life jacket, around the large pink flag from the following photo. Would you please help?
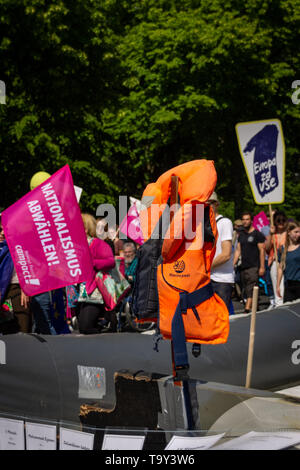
[0,211,137,335]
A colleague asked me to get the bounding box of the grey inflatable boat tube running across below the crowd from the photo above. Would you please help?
[0,302,300,422]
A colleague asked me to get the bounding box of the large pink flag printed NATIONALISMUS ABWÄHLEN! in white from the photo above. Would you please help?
[1,165,93,296]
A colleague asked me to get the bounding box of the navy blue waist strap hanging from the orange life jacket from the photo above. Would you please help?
[172,282,213,370]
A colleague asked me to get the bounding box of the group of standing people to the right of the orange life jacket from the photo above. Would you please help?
[209,192,300,313]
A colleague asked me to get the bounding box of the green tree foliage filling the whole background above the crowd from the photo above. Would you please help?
[0,0,300,219]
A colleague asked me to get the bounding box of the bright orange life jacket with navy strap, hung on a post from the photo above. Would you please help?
[141,160,229,368]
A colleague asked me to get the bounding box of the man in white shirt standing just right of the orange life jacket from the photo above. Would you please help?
[208,192,234,310]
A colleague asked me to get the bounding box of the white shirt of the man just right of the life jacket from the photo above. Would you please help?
[210,214,234,284]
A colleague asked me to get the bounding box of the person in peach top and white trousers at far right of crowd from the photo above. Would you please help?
[266,211,288,307]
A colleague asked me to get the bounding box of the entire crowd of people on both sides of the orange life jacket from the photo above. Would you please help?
[0,192,300,334]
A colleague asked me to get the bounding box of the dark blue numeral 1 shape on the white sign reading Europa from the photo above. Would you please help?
[244,124,279,197]
